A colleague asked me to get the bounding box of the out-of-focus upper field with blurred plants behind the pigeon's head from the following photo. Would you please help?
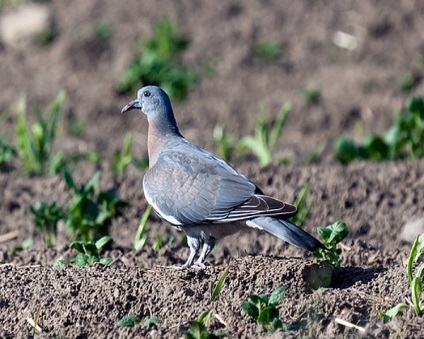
[0,0,424,170]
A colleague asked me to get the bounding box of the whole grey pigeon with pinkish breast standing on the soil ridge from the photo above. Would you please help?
[121,86,325,268]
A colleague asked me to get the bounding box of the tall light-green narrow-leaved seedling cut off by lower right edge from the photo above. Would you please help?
[378,234,424,322]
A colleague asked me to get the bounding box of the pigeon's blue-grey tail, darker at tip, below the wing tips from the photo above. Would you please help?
[246,217,326,252]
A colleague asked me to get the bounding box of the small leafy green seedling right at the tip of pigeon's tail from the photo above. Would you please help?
[312,220,349,267]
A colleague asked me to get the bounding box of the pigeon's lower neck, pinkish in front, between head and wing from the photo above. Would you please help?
[147,121,183,167]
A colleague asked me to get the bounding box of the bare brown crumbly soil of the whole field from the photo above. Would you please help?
[0,0,424,338]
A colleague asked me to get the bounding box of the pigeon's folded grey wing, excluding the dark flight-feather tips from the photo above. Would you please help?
[143,150,256,225]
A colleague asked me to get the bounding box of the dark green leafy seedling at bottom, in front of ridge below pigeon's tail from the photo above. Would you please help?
[241,286,291,332]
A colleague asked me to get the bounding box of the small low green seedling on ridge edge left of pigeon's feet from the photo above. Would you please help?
[55,236,112,268]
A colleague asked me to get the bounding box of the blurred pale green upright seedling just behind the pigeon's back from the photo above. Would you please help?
[239,102,292,166]
